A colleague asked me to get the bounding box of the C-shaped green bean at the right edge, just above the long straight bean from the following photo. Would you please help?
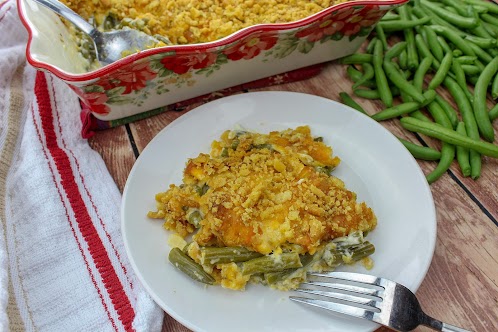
[473,57,498,142]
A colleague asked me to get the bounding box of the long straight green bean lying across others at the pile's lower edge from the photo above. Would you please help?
[400,117,498,158]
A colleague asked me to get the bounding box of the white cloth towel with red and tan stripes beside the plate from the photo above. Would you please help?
[0,0,163,331]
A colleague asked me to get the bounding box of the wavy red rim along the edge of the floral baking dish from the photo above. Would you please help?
[17,0,408,82]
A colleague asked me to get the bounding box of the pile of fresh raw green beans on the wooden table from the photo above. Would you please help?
[340,0,498,183]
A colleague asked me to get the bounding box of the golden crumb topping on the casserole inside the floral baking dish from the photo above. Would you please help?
[62,0,345,44]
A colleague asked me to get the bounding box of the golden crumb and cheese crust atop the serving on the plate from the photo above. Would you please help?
[148,126,377,256]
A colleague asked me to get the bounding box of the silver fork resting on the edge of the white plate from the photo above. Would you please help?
[289,272,469,332]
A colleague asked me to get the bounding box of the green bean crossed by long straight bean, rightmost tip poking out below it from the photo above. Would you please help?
[444,77,482,179]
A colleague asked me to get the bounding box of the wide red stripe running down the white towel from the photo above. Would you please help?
[35,72,135,331]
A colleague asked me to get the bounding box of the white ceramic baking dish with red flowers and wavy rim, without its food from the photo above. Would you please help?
[18,0,406,120]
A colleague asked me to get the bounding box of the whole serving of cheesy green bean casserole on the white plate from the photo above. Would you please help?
[148,126,377,290]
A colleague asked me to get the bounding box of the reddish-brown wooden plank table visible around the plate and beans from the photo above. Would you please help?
[89,62,498,332]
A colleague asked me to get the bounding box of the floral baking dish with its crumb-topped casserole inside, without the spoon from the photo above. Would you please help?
[18,0,407,120]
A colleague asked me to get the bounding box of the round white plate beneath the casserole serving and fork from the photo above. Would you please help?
[121,92,436,332]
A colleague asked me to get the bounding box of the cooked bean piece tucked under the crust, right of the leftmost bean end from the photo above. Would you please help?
[200,247,263,265]
